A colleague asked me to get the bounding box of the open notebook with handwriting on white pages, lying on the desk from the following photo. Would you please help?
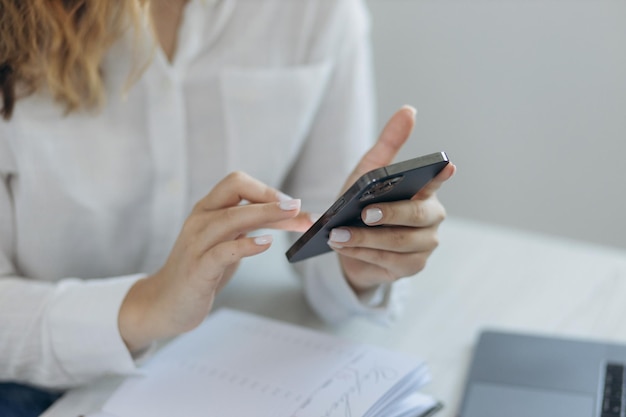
[98,309,441,417]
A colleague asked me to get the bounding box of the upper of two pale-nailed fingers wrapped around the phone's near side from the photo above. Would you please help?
[361,196,446,227]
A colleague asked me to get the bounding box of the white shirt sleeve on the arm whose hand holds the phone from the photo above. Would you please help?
[285,0,408,323]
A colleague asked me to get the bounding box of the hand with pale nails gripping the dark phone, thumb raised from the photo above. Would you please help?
[328,107,456,293]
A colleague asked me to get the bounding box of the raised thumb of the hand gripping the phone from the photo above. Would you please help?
[344,106,417,190]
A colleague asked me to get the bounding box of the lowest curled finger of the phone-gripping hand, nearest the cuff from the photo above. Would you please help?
[337,248,430,287]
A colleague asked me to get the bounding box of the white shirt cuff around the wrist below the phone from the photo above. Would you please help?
[303,253,406,325]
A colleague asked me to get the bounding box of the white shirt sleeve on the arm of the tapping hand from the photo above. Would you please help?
[0,141,141,388]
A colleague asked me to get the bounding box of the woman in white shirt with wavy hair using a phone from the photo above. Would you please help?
[0,0,454,414]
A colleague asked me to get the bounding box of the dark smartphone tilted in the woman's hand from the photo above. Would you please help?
[285,152,449,262]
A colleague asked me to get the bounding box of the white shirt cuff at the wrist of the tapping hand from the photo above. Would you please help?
[44,274,144,385]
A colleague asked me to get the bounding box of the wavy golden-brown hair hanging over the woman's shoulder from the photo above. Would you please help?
[0,0,147,120]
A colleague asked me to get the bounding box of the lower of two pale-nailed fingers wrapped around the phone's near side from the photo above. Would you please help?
[328,227,439,253]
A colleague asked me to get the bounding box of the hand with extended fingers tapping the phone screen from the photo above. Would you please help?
[118,172,312,352]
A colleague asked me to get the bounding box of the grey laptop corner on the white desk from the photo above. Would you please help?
[459,330,626,417]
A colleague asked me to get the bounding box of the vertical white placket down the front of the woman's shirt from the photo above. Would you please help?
[144,0,214,271]
